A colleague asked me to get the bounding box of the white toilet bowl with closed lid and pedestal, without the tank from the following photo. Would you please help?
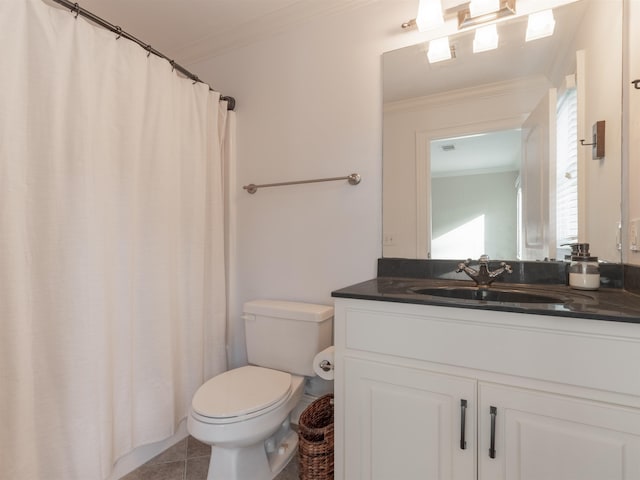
[187,366,304,480]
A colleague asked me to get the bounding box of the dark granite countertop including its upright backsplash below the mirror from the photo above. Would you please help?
[332,258,640,323]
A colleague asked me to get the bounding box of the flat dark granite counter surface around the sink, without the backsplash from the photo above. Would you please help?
[332,277,640,323]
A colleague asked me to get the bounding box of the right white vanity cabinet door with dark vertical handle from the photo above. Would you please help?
[478,383,640,480]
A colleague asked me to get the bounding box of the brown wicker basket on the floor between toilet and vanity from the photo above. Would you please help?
[298,394,333,480]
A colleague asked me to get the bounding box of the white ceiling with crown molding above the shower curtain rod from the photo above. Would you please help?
[52,0,378,67]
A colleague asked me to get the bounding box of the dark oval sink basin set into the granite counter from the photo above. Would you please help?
[412,287,567,304]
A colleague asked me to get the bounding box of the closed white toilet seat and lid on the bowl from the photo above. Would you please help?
[192,365,291,423]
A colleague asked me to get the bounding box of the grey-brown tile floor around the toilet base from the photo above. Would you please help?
[120,436,298,480]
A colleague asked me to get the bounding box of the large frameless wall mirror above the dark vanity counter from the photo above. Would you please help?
[383,0,623,262]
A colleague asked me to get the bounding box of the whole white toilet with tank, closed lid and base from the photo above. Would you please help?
[187,300,333,480]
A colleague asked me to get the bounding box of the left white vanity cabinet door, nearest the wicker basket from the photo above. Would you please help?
[344,357,477,480]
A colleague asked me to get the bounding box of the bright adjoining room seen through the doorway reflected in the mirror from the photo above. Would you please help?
[429,129,522,259]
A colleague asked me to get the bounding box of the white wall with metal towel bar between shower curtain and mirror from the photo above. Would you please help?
[194,0,424,366]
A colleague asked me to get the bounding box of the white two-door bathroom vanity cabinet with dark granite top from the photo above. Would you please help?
[333,268,640,480]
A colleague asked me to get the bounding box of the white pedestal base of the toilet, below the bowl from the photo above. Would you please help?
[207,422,298,480]
